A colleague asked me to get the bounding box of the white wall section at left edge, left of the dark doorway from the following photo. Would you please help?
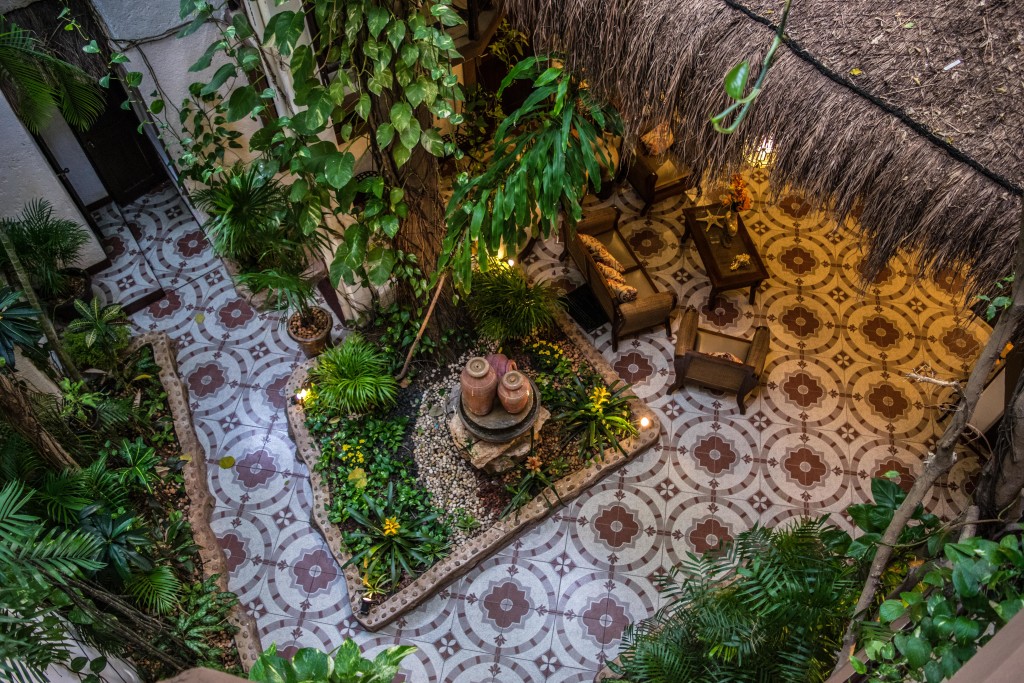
[0,95,106,268]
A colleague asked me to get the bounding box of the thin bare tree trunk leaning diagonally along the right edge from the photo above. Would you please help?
[836,212,1024,670]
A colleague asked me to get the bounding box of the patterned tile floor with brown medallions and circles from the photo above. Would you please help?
[92,171,987,683]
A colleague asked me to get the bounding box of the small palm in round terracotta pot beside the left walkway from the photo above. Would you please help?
[238,270,334,358]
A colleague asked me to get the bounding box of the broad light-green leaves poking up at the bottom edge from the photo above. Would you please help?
[249,638,416,683]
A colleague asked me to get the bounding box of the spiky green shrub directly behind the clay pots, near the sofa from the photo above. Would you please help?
[467,261,558,343]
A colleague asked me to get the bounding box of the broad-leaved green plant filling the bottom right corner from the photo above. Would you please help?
[851,535,1024,683]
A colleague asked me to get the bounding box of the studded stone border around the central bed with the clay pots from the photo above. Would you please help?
[285,311,660,631]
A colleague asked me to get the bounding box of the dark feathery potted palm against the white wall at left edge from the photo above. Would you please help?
[0,200,92,317]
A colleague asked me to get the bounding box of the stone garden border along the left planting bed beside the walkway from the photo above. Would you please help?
[131,332,263,671]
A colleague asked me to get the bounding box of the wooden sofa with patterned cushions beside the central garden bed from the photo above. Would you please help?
[561,207,676,351]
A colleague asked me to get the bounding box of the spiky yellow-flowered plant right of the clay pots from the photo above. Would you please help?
[552,376,637,458]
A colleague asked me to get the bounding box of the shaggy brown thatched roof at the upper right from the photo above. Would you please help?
[505,0,1024,288]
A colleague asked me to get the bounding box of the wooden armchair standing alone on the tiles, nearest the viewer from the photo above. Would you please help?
[669,306,770,415]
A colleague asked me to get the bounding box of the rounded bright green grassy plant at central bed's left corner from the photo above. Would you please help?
[309,333,398,414]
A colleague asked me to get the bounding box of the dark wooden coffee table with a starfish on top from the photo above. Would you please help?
[683,206,768,305]
